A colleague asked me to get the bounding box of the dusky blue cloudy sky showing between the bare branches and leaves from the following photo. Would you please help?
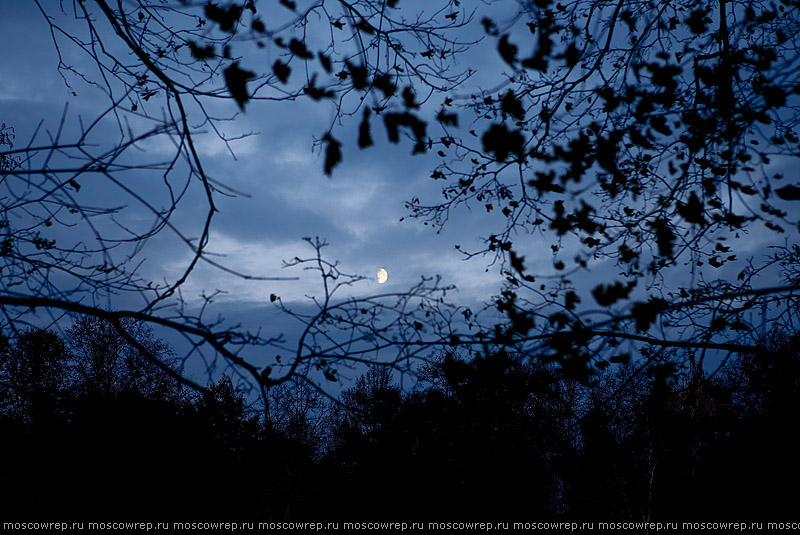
[0,2,797,394]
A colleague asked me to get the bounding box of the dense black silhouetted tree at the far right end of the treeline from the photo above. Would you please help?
[702,329,800,518]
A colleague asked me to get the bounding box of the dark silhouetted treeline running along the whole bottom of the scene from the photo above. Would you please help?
[0,319,800,521]
